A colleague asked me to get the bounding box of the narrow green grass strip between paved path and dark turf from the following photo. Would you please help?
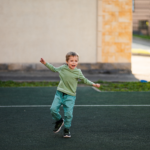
[0,80,150,92]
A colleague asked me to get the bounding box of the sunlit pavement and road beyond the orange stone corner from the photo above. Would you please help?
[132,38,150,81]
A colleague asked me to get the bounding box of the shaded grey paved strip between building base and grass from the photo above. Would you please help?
[0,71,139,82]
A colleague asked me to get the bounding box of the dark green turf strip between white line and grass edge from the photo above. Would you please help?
[0,87,150,106]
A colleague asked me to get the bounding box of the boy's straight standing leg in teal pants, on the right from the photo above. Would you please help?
[63,95,76,129]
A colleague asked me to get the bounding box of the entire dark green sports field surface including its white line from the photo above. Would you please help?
[0,87,150,150]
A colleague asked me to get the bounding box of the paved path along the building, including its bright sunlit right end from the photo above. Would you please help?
[0,56,150,82]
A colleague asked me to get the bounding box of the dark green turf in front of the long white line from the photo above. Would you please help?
[0,107,150,150]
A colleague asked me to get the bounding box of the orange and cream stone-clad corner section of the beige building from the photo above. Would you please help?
[97,0,132,70]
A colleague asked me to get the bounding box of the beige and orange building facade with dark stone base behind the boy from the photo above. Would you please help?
[0,0,132,72]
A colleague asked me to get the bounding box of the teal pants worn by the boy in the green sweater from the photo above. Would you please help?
[50,91,76,128]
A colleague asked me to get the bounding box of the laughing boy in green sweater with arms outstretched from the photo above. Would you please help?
[40,52,100,137]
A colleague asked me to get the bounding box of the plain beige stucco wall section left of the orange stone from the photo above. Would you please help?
[0,0,97,63]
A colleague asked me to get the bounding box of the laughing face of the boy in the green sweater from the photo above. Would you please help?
[66,56,78,69]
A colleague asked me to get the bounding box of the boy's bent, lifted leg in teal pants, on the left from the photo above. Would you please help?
[50,91,62,121]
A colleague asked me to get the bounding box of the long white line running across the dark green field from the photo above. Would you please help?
[0,105,150,108]
